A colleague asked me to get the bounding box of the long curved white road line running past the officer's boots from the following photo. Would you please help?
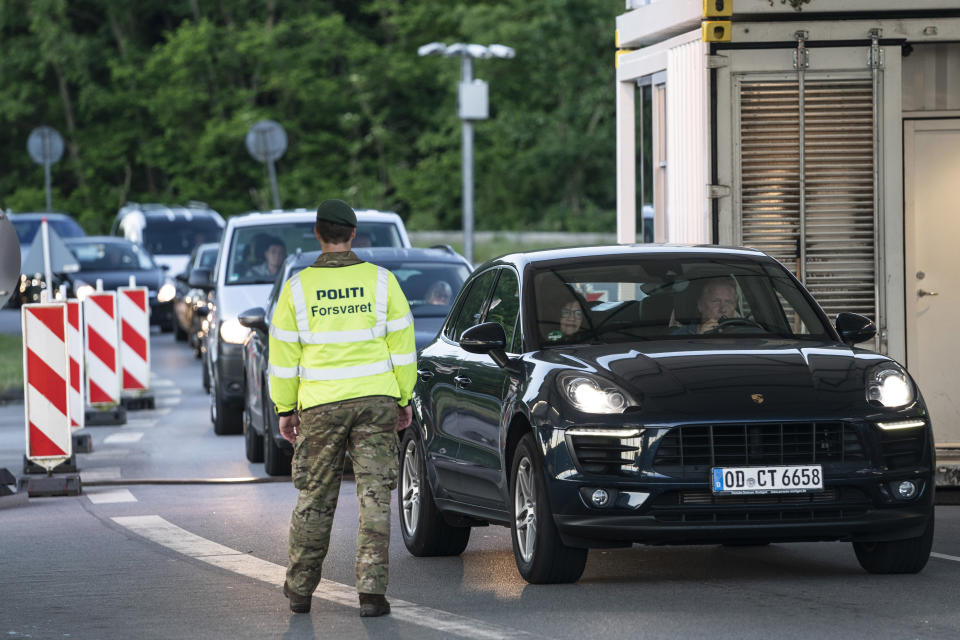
[113,516,541,640]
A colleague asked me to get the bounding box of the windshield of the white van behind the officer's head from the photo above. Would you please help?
[226,220,406,284]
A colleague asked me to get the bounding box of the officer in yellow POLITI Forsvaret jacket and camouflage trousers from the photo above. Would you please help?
[270,200,417,617]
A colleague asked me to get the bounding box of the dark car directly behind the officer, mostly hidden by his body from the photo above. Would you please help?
[240,247,470,475]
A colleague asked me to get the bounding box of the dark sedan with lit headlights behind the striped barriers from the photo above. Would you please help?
[64,236,176,331]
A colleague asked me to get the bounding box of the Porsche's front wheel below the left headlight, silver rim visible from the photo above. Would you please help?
[510,433,587,584]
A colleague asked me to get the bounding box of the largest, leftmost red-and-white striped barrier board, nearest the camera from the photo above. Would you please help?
[20,303,73,470]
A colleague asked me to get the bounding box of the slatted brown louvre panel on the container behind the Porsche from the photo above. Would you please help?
[738,79,876,320]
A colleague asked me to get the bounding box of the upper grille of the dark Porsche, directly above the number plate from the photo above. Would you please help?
[653,422,866,477]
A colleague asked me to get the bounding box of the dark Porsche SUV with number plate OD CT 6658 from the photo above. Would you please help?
[398,245,935,583]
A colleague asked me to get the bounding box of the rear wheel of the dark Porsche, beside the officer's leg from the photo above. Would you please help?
[397,428,470,558]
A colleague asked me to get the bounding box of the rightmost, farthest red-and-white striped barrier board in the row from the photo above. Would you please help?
[117,286,150,392]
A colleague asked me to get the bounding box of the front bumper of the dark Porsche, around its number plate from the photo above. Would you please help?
[539,423,935,547]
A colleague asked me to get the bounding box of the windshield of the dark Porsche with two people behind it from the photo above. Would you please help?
[533,256,831,347]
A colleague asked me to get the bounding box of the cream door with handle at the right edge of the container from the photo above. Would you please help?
[903,119,960,446]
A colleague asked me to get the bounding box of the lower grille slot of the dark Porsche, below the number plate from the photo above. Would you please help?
[650,487,871,523]
